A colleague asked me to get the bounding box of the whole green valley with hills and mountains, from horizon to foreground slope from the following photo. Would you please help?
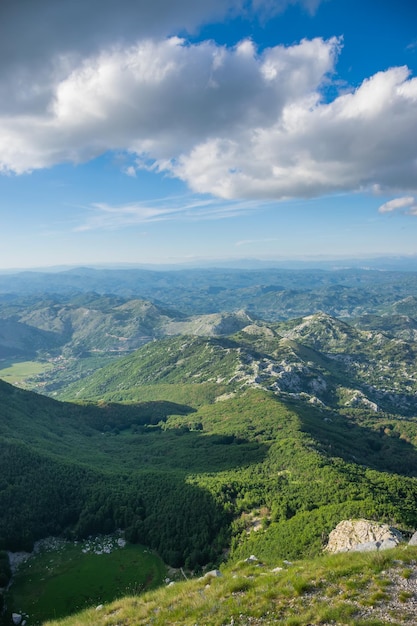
[0,269,417,626]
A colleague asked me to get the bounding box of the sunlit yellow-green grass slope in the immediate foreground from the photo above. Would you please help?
[39,548,417,626]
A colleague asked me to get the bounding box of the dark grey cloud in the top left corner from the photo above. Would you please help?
[0,0,322,113]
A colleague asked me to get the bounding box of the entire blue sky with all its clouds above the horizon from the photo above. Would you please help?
[0,0,417,269]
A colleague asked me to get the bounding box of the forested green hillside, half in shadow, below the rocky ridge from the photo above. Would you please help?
[0,376,417,567]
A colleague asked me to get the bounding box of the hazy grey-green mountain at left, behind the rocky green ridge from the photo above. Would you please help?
[0,294,183,357]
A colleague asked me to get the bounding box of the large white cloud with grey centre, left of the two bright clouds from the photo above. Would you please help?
[0,37,339,173]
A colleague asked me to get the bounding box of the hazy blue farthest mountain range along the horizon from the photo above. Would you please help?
[0,268,417,320]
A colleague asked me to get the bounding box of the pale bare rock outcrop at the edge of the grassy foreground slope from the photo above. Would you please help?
[326,519,403,552]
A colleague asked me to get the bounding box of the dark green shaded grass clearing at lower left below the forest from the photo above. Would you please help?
[7,539,166,626]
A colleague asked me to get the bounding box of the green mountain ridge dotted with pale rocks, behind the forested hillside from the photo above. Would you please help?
[61,313,417,415]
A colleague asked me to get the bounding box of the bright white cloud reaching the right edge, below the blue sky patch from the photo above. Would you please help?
[173,68,417,198]
